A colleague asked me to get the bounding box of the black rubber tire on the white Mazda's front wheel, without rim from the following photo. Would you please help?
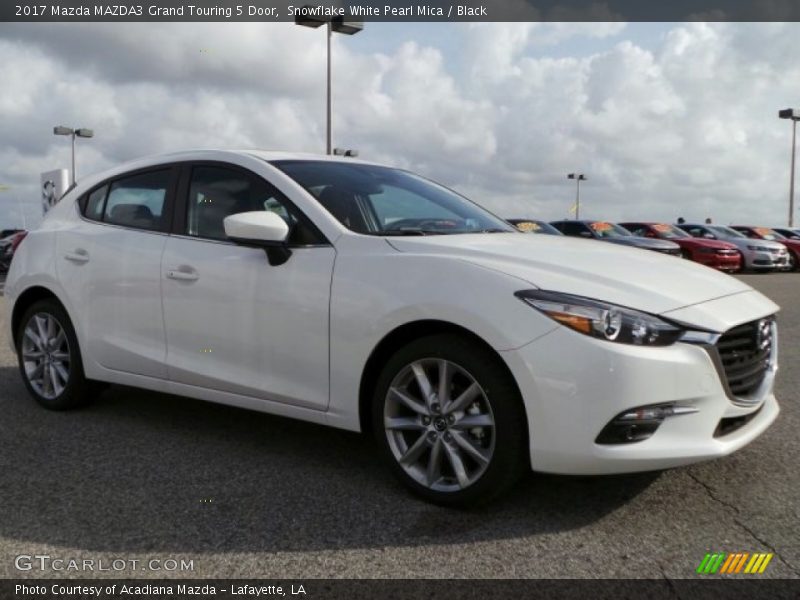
[372,334,530,507]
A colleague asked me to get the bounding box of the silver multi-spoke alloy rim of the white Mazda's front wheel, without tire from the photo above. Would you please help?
[384,358,495,492]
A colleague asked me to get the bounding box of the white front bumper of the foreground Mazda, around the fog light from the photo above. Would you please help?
[502,327,779,475]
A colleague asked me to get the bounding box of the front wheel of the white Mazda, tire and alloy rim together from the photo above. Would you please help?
[373,334,528,505]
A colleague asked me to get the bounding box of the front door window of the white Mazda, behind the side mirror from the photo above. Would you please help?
[185,166,320,244]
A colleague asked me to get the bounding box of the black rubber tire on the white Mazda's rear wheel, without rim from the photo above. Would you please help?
[17,299,101,410]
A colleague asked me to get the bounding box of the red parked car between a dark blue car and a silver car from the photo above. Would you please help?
[620,222,742,273]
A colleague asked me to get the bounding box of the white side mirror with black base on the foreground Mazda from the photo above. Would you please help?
[222,210,292,266]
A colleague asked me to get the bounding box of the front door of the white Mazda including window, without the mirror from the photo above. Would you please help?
[161,164,335,410]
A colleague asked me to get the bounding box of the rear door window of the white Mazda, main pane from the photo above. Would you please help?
[104,169,170,231]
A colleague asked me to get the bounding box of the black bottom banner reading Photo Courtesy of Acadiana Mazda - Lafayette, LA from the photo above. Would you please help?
[0,578,800,600]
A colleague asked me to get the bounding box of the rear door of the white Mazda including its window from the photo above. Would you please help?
[56,166,177,378]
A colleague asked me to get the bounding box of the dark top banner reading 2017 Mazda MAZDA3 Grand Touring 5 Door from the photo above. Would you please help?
[0,0,800,22]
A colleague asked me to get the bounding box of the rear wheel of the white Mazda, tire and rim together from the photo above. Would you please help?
[17,299,94,410]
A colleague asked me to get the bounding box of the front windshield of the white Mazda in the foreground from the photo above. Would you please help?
[271,160,516,235]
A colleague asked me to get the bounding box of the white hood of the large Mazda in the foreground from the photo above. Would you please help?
[386,233,756,314]
